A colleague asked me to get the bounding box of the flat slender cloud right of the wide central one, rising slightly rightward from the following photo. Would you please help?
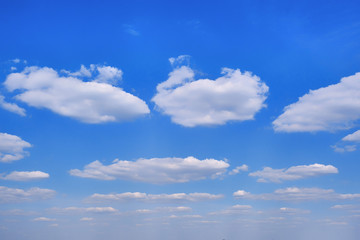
[249,163,338,183]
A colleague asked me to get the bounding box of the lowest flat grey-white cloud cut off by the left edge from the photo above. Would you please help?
[0,186,56,203]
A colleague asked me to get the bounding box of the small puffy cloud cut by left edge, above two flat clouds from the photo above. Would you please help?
[0,133,31,162]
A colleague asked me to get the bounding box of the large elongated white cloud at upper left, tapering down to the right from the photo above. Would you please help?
[4,65,149,123]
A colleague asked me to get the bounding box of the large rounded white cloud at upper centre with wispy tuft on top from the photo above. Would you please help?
[152,56,269,127]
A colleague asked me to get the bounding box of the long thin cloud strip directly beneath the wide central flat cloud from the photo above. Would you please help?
[86,192,224,202]
